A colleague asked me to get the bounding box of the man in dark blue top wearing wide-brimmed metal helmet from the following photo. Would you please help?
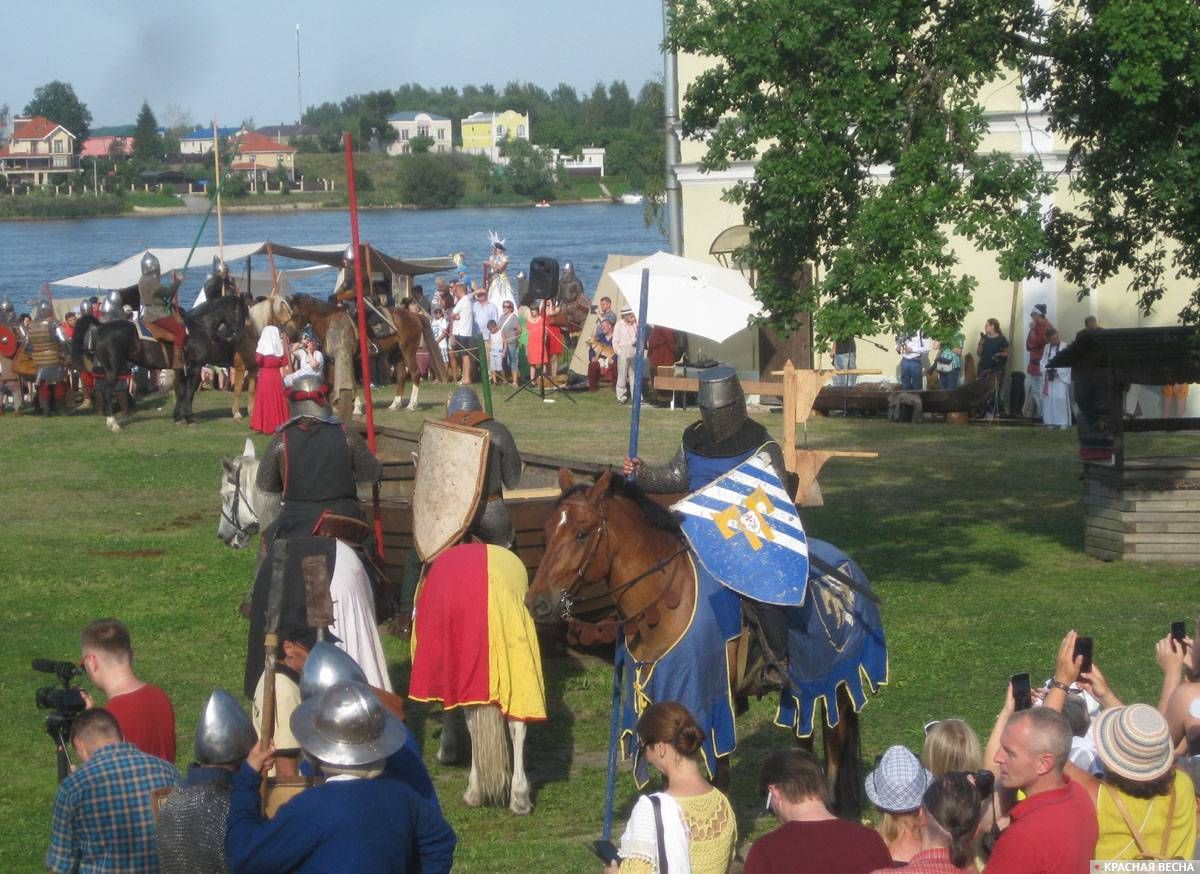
[226,683,455,874]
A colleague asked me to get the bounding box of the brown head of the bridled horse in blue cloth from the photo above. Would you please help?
[526,468,612,623]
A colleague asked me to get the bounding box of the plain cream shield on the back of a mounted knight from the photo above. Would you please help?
[413,421,492,562]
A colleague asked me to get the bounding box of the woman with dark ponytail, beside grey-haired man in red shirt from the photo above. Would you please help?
[871,772,980,874]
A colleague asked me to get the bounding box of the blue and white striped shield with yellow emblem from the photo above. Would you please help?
[671,453,809,606]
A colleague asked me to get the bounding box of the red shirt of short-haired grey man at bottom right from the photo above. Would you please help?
[984,777,1099,874]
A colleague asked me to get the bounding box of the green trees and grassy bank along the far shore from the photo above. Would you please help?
[0,80,664,219]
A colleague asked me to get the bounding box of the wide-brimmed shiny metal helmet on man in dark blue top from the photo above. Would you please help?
[292,683,408,767]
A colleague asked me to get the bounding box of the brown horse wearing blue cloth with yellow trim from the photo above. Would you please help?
[526,471,887,815]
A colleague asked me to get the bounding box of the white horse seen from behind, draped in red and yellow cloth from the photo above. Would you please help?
[409,544,546,815]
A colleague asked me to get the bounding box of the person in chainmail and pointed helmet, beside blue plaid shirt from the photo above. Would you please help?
[157,689,258,874]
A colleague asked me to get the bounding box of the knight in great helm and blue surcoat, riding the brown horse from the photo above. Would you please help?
[623,366,794,681]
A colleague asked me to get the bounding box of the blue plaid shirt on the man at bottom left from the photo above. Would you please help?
[46,743,180,874]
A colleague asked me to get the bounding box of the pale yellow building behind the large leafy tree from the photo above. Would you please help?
[677,55,1200,415]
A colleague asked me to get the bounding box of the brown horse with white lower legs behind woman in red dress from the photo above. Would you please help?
[288,294,448,420]
